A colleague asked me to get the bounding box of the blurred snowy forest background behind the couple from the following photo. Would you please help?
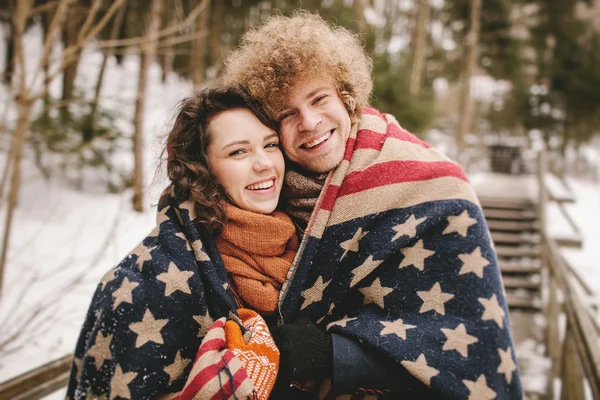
[0,0,600,396]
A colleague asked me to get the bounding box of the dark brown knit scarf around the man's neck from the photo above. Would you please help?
[281,170,327,230]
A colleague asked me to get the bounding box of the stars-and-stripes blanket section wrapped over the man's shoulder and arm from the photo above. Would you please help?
[279,109,522,399]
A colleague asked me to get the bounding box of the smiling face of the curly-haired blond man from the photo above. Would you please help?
[278,79,352,172]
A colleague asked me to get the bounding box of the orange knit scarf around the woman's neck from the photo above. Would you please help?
[217,204,298,315]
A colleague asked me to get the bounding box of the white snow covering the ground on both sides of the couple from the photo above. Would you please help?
[0,23,600,398]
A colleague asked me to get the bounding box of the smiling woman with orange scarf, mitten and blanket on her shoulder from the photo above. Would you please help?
[67,88,298,399]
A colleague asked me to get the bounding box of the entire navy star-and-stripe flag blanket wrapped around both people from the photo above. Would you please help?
[67,109,521,400]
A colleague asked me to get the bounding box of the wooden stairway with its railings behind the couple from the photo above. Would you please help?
[0,151,600,400]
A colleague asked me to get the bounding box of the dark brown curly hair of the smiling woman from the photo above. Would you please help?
[166,86,277,233]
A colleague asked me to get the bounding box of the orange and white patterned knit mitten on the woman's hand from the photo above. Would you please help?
[225,308,279,400]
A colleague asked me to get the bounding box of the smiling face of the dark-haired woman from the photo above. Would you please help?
[208,108,285,214]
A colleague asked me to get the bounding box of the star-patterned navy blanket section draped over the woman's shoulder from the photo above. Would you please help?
[67,190,247,400]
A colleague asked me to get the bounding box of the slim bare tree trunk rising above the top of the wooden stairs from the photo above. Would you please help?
[456,0,481,152]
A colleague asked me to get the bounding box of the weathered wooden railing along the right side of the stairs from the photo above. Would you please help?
[538,145,600,400]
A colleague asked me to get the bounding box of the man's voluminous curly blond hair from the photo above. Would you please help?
[223,11,373,121]
